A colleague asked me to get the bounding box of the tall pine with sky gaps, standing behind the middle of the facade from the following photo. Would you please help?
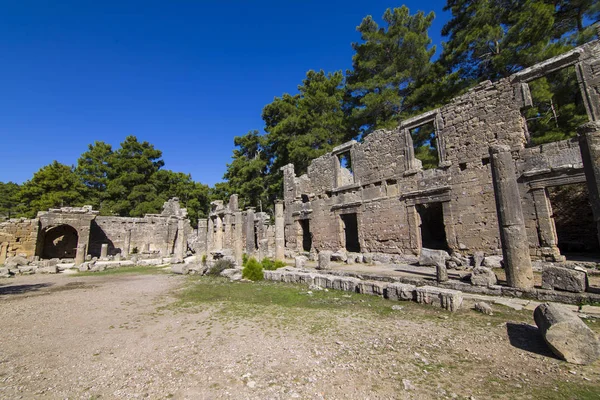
[347,6,435,135]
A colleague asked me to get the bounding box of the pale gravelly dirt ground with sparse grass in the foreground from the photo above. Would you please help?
[0,273,600,399]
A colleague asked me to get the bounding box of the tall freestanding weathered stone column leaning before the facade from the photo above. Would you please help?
[490,145,534,289]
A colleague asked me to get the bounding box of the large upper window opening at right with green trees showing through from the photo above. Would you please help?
[522,66,588,146]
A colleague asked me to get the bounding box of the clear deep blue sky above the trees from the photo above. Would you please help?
[0,0,449,185]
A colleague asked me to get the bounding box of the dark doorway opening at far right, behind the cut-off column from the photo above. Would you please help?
[547,183,600,255]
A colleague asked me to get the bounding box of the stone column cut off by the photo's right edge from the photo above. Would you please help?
[578,121,600,248]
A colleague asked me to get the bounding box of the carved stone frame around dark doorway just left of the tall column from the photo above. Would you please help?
[400,186,458,255]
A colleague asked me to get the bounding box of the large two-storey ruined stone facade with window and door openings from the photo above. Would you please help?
[282,41,600,268]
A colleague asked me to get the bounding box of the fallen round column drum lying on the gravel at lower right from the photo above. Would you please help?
[533,303,600,365]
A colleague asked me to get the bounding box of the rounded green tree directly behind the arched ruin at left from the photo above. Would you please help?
[19,161,87,218]
